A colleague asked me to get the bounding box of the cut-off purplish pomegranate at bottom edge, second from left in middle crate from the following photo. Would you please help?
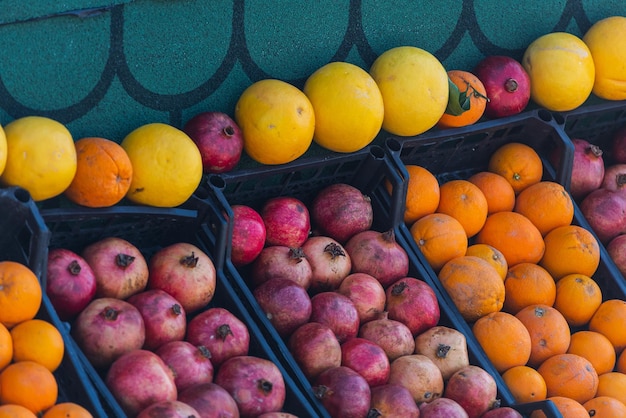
[368,383,420,418]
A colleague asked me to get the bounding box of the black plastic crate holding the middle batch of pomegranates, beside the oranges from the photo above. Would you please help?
[209,146,559,417]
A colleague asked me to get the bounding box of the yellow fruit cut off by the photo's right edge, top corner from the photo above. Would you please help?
[583,16,626,100]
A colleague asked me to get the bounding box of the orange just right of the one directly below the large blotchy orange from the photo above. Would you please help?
[515,305,571,366]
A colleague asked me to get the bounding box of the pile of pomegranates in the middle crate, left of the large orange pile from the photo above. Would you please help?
[231,183,521,418]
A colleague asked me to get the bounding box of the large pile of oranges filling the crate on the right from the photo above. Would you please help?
[405,142,626,417]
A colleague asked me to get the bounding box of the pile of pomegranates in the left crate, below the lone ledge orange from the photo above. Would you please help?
[46,237,290,418]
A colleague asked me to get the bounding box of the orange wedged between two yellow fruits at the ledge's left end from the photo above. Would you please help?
[65,138,133,208]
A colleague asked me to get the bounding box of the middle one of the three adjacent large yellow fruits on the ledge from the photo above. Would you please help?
[303,62,385,152]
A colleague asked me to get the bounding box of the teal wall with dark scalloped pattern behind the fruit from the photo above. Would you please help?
[0,0,626,141]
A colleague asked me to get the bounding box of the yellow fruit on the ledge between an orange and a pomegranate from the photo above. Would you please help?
[120,123,202,207]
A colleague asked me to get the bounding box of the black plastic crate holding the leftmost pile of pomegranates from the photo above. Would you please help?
[41,188,315,417]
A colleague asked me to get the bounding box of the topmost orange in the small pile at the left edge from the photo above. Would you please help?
[0,261,42,329]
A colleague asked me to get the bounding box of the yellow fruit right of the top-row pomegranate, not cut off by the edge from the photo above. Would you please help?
[522,32,595,112]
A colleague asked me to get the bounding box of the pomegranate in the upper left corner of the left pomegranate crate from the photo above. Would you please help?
[46,248,96,321]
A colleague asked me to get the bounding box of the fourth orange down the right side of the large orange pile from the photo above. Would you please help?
[554,274,602,327]
